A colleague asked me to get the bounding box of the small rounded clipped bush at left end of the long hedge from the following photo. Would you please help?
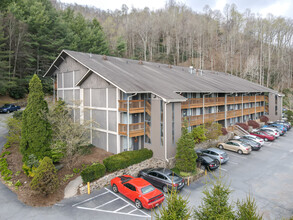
[80,163,106,183]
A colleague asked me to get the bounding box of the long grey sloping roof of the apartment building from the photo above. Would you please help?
[44,50,277,102]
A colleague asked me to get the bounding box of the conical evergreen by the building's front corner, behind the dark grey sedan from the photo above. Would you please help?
[175,131,197,172]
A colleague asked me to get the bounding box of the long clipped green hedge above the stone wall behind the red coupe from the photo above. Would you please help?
[103,148,153,172]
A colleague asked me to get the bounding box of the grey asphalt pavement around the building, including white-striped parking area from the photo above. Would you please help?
[0,111,293,220]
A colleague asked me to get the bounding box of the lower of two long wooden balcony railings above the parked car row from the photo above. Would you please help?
[182,106,264,126]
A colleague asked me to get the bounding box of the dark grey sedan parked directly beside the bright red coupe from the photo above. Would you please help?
[138,168,185,193]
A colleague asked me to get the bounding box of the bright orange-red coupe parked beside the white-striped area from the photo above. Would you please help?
[111,175,165,209]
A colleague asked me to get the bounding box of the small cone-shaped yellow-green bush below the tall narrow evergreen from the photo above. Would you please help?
[30,157,59,195]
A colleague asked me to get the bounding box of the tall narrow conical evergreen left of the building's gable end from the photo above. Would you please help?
[20,75,52,162]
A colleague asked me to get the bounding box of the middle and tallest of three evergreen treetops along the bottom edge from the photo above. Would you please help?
[194,178,235,220]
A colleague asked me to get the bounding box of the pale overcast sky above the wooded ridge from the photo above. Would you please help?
[60,0,293,18]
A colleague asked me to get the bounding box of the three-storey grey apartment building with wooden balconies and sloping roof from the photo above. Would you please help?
[44,50,282,160]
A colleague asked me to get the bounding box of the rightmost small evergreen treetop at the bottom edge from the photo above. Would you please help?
[236,195,263,220]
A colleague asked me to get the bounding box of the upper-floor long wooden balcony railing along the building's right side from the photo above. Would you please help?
[181,96,265,109]
